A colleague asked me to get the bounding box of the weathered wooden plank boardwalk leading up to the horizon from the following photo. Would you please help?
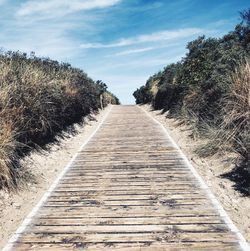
[3,106,248,251]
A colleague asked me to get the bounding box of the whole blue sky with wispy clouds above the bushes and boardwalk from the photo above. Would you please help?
[0,0,250,104]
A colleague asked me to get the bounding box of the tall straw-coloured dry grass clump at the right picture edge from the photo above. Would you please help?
[222,61,250,164]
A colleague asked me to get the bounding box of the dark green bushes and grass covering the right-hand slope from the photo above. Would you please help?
[134,9,250,194]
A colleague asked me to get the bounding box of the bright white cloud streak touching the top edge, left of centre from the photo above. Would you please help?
[17,0,121,16]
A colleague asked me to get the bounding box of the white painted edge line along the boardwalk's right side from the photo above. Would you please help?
[138,106,250,251]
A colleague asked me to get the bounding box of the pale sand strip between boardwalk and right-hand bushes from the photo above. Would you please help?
[142,105,250,243]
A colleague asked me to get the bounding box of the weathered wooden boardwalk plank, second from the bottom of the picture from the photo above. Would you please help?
[19,231,236,246]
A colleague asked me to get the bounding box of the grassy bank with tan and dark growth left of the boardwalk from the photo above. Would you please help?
[0,52,119,188]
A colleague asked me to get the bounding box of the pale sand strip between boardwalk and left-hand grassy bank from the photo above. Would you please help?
[0,107,111,249]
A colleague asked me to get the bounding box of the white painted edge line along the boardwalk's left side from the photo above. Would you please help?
[2,105,113,251]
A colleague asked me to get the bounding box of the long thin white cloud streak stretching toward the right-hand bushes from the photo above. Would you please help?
[80,28,204,49]
